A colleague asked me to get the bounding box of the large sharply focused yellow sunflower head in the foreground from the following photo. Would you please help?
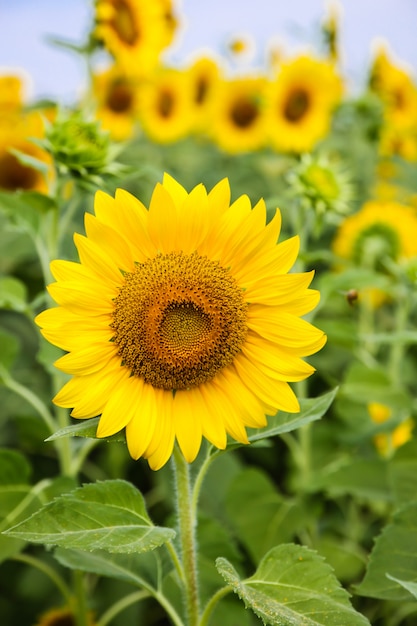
[36,175,325,469]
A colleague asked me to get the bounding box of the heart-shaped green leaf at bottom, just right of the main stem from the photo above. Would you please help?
[216,544,369,626]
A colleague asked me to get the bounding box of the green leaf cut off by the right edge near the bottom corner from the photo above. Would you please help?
[356,502,417,601]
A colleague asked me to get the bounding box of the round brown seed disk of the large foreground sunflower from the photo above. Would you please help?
[112,252,247,390]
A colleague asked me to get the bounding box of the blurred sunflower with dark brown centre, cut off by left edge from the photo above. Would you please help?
[0,111,52,192]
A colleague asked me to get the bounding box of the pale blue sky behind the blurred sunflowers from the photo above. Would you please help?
[0,0,417,102]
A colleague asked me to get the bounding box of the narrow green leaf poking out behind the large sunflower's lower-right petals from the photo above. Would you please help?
[249,388,338,442]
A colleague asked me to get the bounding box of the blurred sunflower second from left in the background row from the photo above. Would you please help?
[138,68,194,143]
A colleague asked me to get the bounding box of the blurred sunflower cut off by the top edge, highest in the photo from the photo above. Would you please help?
[94,0,167,75]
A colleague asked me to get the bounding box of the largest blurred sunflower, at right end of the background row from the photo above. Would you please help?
[266,56,342,153]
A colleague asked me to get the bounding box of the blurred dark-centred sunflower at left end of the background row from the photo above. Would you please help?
[93,65,139,141]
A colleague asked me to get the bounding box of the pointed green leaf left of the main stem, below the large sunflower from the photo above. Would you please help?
[7,480,175,553]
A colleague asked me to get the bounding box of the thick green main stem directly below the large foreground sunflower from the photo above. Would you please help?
[172,446,199,626]
